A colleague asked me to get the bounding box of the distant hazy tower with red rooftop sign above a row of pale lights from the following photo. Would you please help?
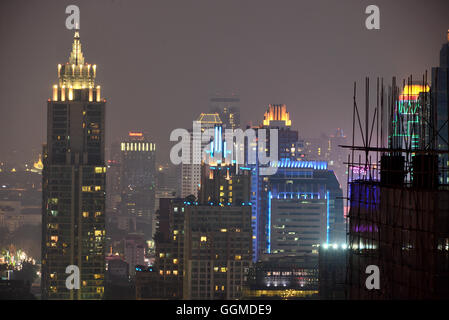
[120,132,156,239]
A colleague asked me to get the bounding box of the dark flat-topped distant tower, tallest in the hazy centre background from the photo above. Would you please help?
[209,93,240,129]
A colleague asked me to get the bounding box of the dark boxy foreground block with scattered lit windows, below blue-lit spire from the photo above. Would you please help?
[183,205,252,300]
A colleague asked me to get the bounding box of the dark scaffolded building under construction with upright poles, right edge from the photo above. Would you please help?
[342,73,449,299]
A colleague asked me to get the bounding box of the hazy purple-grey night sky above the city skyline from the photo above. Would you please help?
[0,0,449,164]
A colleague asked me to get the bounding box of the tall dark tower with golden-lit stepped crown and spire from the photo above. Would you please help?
[42,31,106,299]
